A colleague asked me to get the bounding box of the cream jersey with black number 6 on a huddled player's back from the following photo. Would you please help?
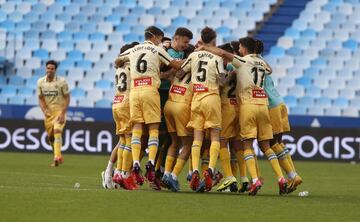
[129,41,170,88]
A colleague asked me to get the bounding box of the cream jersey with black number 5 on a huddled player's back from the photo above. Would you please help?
[183,51,225,94]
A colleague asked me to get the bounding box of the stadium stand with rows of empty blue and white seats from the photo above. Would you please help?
[0,0,360,116]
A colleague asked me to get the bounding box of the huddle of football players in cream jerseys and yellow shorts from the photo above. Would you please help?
[102,26,302,195]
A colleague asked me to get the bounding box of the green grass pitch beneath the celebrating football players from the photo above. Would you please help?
[0,152,360,222]
